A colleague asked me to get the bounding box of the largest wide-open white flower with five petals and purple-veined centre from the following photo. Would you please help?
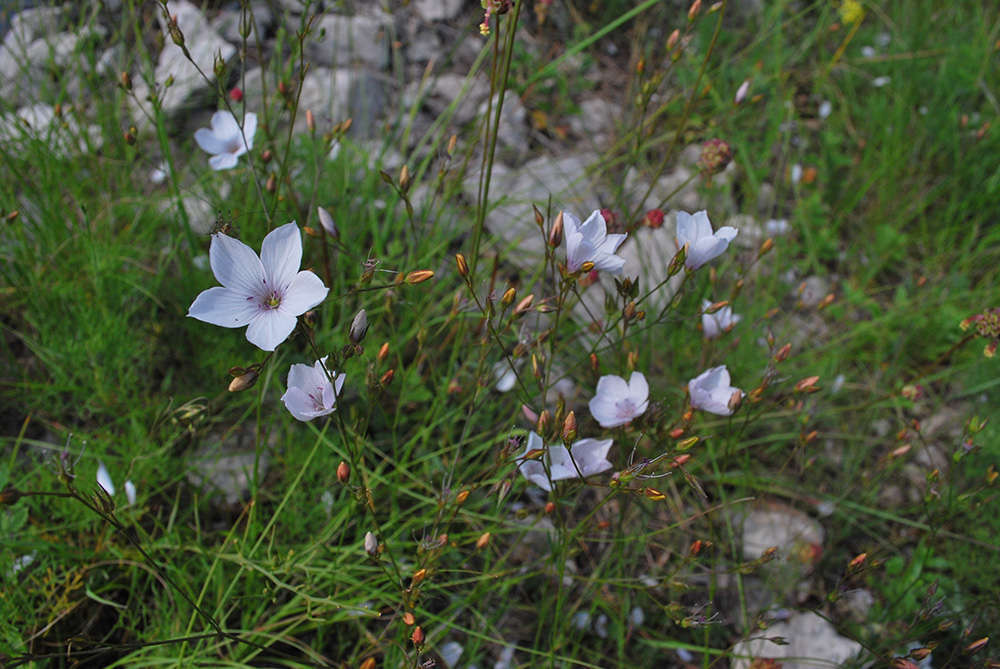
[188,221,328,351]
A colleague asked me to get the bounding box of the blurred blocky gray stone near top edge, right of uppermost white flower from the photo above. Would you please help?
[306,12,390,69]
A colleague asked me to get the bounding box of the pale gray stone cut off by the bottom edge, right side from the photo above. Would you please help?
[730,611,861,669]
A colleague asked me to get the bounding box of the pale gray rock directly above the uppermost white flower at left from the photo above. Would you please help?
[132,0,236,129]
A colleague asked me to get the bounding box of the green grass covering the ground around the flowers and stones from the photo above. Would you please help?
[0,0,1000,667]
